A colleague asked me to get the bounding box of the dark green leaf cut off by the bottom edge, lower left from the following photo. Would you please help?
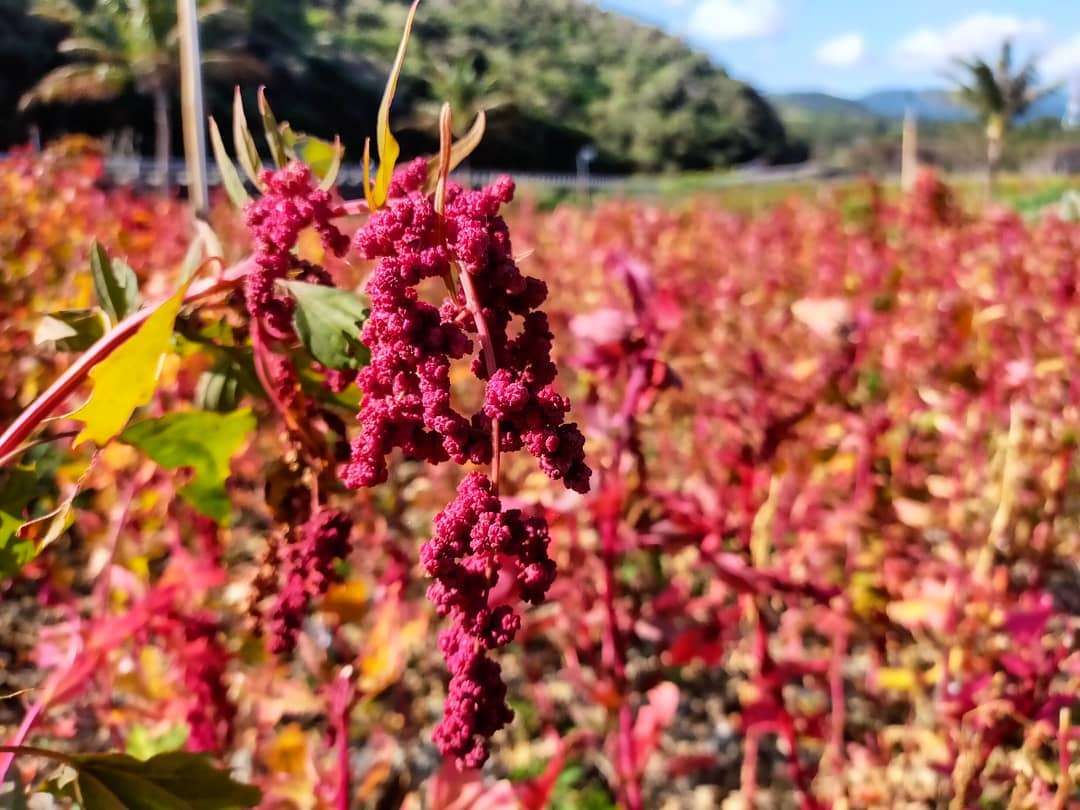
[71,752,262,810]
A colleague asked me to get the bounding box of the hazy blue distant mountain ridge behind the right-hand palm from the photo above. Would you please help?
[770,87,1068,122]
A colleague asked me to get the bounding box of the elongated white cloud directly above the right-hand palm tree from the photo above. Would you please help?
[895,12,1049,69]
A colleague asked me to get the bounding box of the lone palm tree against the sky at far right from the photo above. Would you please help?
[953,40,1056,190]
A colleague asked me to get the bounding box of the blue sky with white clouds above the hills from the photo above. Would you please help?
[593,0,1080,95]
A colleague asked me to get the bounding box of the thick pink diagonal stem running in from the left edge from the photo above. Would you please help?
[0,257,255,462]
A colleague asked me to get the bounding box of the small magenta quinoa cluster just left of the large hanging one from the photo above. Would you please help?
[244,162,349,338]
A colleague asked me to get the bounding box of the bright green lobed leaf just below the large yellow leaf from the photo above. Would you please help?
[120,408,255,523]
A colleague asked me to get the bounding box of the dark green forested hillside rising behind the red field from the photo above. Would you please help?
[0,0,801,171]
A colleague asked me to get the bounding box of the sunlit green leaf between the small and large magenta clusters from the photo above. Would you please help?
[282,281,369,369]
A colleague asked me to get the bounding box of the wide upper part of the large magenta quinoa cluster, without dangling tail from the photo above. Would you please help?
[343,156,591,492]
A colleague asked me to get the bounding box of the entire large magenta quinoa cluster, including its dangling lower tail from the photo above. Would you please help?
[342,161,591,768]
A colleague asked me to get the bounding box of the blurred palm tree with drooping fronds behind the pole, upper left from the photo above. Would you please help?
[19,0,261,178]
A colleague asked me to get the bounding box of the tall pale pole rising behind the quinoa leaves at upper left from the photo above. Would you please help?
[176,0,210,219]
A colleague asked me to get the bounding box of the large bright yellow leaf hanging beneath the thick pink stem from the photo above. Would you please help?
[67,284,188,447]
